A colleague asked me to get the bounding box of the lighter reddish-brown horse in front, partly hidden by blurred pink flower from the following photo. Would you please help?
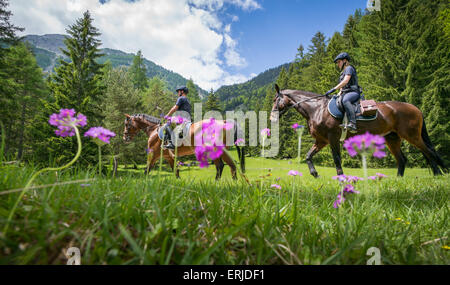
[123,114,245,180]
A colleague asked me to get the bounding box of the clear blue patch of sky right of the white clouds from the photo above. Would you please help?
[223,0,366,74]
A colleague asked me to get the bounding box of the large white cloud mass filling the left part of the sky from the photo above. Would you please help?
[9,0,261,90]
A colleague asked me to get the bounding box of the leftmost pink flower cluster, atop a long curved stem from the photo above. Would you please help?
[48,109,87,137]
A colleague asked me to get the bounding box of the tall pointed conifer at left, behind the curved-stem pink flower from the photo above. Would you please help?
[42,11,104,163]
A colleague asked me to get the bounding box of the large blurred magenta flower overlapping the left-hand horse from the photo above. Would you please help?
[195,118,233,168]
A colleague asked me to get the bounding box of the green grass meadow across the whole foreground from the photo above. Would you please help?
[0,155,450,264]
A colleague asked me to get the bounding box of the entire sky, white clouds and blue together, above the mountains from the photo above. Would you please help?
[10,0,367,90]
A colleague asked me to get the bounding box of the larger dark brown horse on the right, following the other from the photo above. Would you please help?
[270,85,448,177]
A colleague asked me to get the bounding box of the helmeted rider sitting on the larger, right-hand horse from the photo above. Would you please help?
[325,52,361,133]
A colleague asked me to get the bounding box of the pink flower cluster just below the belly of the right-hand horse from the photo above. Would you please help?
[344,132,386,158]
